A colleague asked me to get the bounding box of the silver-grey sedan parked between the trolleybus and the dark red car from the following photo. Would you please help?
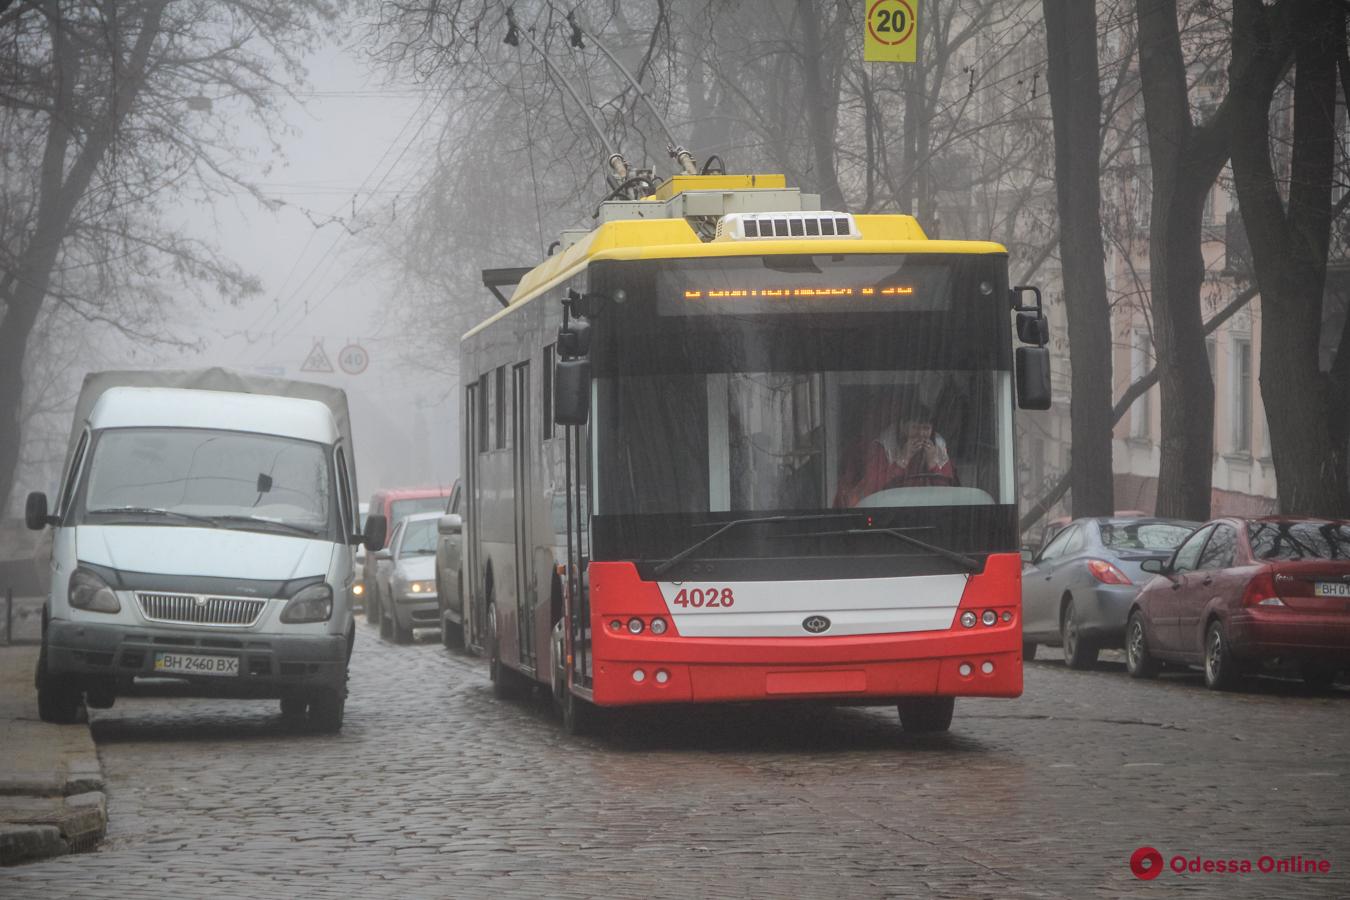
[1022,518,1195,669]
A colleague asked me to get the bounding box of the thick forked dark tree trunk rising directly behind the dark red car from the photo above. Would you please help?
[1233,0,1350,517]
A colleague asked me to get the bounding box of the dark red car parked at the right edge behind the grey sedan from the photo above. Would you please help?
[1125,517,1350,690]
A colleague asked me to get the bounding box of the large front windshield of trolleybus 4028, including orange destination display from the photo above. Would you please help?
[590,254,1015,577]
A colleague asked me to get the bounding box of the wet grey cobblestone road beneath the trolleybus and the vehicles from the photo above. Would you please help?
[0,625,1350,899]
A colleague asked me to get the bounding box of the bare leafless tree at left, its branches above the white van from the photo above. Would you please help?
[0,0,335,512]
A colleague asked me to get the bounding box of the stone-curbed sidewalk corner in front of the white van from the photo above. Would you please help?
[0,646,108,865]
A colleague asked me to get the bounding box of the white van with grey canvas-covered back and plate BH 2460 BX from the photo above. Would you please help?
[26,368,386,731]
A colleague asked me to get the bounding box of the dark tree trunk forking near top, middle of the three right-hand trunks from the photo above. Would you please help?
[1138,0,1233,521]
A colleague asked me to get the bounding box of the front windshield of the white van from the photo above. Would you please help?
[84,428,332,534]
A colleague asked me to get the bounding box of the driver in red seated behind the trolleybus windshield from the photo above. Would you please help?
[834,403,959,507]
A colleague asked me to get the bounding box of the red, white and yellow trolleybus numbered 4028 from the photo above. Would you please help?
[460,175,1049,731]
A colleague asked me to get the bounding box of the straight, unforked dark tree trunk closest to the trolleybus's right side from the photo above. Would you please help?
[1044,0,1115,517]
